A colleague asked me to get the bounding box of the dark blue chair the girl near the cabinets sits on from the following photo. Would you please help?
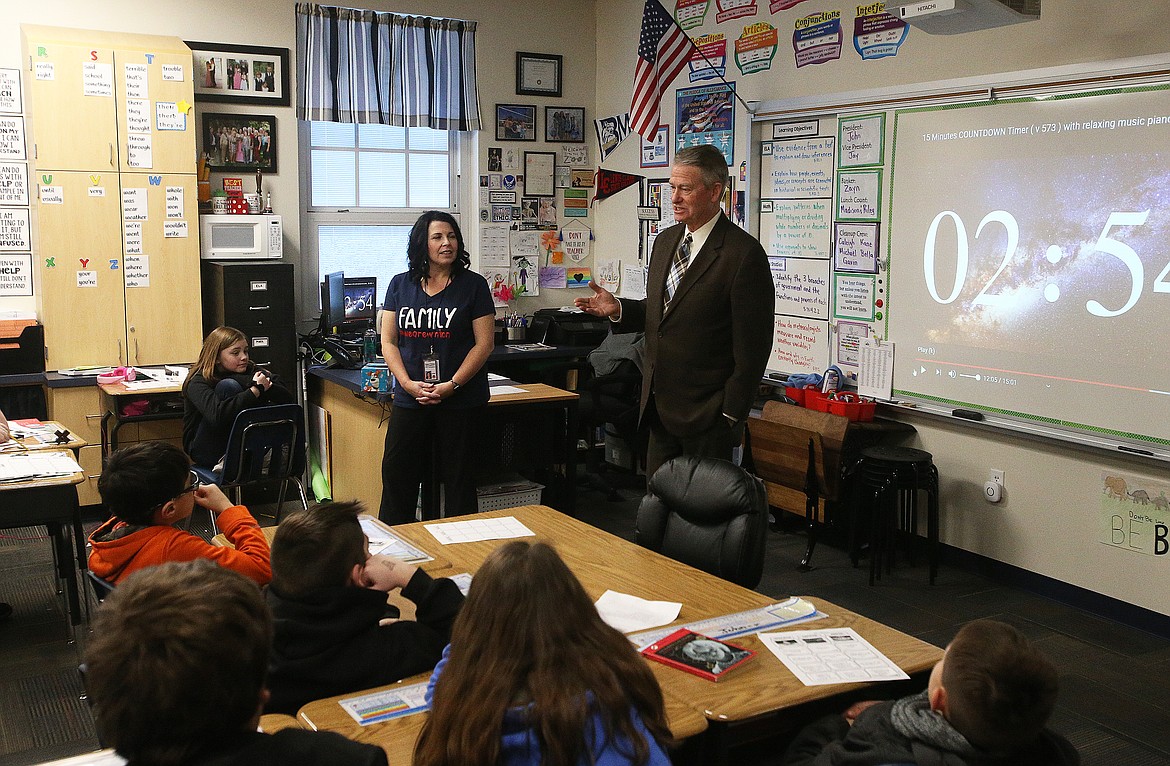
[194,405,309,523]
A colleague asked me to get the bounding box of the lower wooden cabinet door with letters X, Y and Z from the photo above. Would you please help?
[34,170,126,370]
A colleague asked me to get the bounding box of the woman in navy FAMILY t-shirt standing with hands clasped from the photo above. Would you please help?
[379,211,495,524]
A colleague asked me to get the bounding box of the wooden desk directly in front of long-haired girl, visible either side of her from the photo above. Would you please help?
[297,672,707,764]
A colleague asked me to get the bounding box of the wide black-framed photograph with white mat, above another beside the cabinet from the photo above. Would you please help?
[187,41,290,106]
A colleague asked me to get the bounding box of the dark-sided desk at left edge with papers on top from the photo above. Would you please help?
[0,450,85,624]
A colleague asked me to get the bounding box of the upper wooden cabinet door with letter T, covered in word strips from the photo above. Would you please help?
[113,47,195,173]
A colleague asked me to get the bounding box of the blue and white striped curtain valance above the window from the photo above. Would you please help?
[296,2,480,130]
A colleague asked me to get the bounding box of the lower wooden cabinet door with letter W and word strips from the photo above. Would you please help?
[122,173,202,365]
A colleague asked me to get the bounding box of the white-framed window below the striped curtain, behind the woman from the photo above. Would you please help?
[301,122,470,315]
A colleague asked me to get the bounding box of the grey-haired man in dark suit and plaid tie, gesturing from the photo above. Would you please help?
[576,146,775,476]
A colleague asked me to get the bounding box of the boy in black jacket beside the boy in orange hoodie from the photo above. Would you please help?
[266,502,463,713]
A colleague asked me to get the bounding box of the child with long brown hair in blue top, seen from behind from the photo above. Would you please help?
[413,540,672,766]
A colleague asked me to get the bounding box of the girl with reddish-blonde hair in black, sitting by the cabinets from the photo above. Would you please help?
[183,327,295,471]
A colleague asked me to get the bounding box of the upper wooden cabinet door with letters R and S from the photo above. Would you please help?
[25,39,118,172]
